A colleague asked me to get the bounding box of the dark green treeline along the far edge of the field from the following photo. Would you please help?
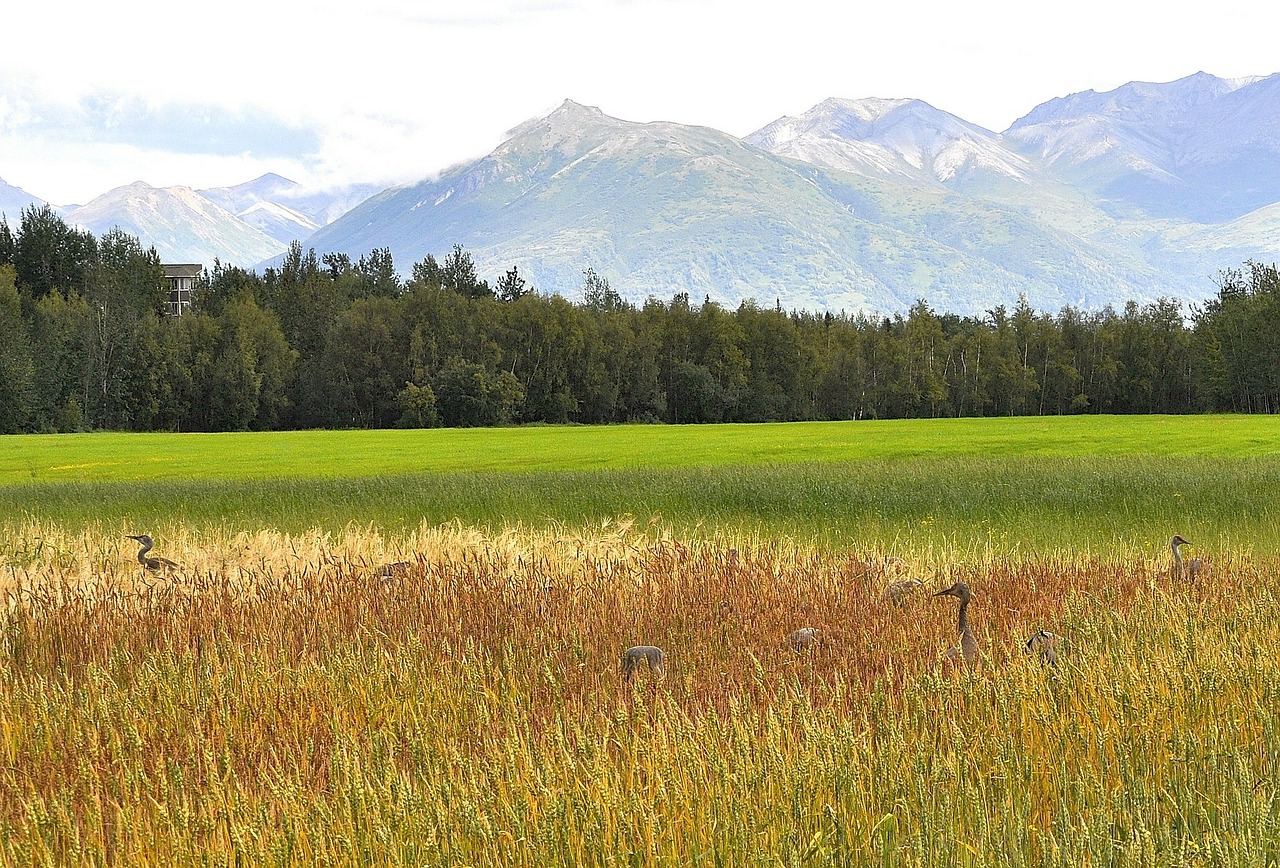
[0,209,1280,431]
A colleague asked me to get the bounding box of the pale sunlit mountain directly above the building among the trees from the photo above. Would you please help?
[68,181,287,266]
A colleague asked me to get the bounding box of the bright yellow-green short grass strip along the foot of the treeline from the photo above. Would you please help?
[0,416,1280,486]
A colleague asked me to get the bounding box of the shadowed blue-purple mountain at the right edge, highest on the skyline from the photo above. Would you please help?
[1004,73,1280,223]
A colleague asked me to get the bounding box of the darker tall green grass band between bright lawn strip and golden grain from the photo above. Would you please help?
[0,456,1280,556]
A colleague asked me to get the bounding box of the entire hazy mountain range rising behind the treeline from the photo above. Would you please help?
[0,73,1280,314]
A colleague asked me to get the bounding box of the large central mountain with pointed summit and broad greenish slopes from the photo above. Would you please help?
[306,101,1167,312]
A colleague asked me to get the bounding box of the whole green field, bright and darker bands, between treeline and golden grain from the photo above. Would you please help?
[0,416,1280,553]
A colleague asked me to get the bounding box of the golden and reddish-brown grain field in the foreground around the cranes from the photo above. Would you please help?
[0,521,1280,865]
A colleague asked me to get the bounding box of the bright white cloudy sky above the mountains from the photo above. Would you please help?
[0,0,1280,205]
